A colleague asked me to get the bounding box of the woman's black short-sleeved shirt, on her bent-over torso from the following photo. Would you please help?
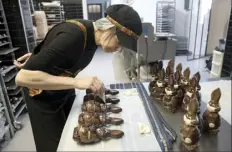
[23,20,97,100]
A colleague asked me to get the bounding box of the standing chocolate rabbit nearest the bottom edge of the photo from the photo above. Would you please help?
[180,99,201,150]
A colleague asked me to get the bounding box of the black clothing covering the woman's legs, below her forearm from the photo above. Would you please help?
[25,89,75,152]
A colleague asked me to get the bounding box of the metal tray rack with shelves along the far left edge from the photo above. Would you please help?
[0,0,26,147]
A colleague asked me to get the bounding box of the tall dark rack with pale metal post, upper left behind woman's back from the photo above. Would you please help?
[3,0,36,58]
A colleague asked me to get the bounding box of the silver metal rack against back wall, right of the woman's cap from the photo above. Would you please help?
[156,1,175,33]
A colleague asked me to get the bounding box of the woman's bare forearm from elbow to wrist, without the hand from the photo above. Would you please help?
[15,69,78,90]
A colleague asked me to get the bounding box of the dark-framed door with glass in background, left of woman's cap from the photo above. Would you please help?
[88,4,103,21]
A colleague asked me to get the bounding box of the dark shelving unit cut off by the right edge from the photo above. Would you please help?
[221,6,232,78]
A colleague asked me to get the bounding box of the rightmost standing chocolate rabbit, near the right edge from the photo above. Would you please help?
[203,88,221,134]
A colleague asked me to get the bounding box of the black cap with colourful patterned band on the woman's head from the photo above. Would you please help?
[105,4,142,52]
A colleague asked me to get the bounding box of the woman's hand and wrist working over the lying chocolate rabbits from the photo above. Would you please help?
[76,77,105,93]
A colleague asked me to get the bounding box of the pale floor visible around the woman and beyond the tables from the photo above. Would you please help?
[3,49,216,151]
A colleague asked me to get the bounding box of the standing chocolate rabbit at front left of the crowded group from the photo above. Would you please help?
[163,75,178,113]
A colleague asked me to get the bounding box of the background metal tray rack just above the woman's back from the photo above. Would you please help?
[39,4,64,25]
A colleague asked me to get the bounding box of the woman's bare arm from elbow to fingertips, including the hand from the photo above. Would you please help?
[15,69,105,94]
